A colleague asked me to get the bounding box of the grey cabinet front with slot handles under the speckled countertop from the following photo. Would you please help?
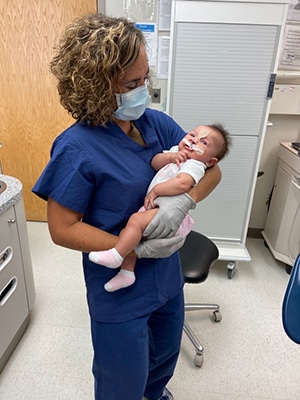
[0,200,35,372]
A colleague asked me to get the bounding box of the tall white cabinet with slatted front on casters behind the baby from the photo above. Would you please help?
[167,0,288,278]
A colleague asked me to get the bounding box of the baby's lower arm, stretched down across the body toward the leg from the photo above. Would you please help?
[144,172,195,209]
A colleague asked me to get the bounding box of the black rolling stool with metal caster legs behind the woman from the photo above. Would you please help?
[180,231,222,367]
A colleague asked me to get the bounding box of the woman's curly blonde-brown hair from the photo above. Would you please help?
[50,14,146,126]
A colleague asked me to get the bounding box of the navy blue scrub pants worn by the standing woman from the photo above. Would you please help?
[91,292,184,400]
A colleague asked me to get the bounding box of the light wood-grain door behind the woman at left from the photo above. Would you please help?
[0,0,97,221]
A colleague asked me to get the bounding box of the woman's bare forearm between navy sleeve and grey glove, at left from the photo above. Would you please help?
[47,198,118,253]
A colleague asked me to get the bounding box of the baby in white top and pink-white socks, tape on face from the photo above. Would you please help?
[89,124,231,292]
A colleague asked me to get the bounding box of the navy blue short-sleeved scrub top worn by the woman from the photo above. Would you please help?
[32,109,185,322]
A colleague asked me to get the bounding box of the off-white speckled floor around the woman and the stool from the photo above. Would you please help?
[0,223,300,400]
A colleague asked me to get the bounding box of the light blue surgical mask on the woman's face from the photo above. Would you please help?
[114,85,150,121]
